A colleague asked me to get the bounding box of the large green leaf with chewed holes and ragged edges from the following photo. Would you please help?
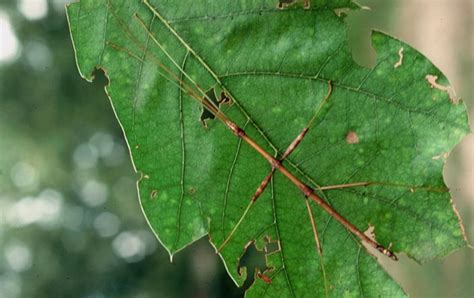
[68,0,469,297]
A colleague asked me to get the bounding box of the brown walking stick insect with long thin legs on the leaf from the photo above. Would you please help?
[106,0,401,260]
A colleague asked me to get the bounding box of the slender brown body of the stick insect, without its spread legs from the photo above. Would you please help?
[105,7,398,260]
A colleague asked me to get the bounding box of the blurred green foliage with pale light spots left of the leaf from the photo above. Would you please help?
[0,1,242,298]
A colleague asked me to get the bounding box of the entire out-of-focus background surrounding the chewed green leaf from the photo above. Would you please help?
[0,0,474,298]
